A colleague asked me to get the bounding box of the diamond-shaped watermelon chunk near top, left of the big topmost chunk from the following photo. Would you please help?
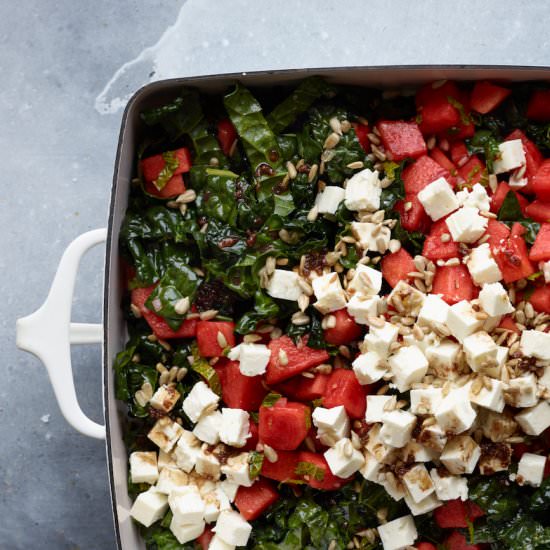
[376,120,427,162]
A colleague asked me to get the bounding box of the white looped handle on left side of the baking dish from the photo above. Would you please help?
[16,229,107,439]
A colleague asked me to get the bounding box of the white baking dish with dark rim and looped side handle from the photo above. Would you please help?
[17,66,550,550]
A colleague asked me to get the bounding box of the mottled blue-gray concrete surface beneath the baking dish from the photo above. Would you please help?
[0,0,550,550]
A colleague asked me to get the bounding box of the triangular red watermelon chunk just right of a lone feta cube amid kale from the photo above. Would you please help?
[266,335,329,384]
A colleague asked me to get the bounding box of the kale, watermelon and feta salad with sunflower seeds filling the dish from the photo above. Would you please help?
[114,77,550,550]
